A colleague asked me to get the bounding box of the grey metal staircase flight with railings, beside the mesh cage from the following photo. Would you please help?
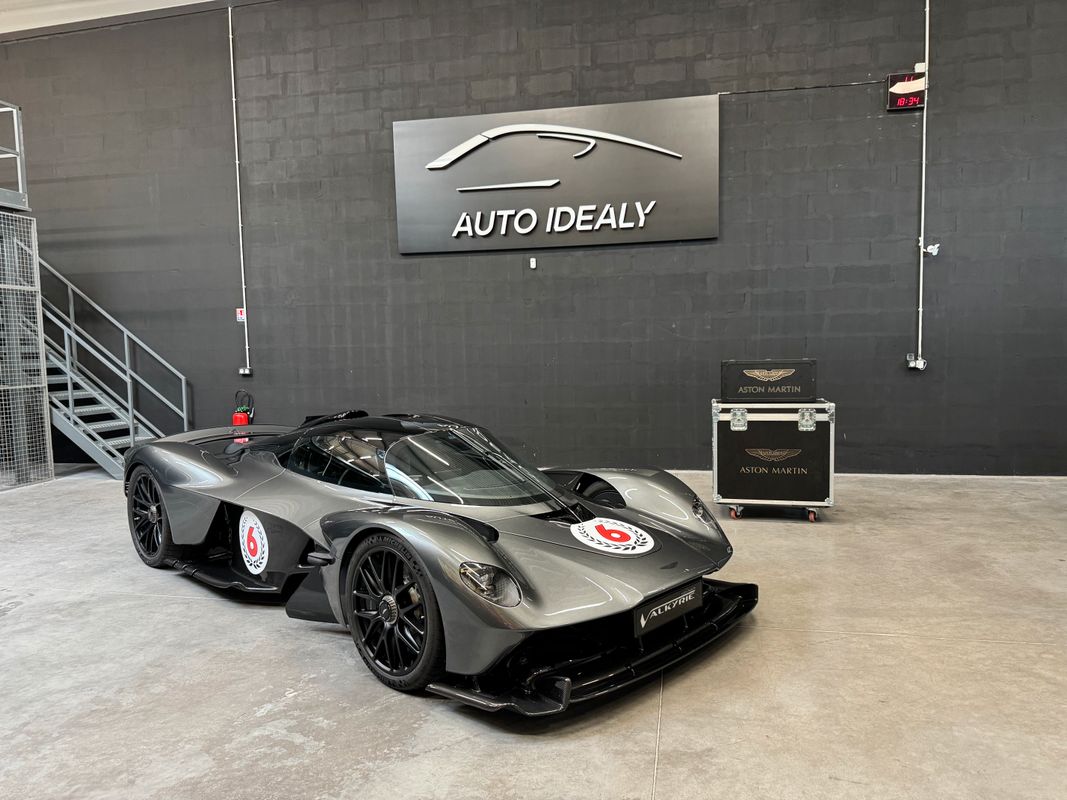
[28,247,189,478]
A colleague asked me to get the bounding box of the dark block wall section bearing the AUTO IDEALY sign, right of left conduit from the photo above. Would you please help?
[0,0,1067,473]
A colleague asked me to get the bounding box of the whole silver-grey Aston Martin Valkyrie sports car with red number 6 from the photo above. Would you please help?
[125,411,758,716]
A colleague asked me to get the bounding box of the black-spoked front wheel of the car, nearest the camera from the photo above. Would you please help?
[341,532,445,691]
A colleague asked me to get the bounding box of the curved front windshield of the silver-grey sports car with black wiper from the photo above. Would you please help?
[385,428,558,506]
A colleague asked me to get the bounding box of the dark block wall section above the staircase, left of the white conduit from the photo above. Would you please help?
[0,11,244,435]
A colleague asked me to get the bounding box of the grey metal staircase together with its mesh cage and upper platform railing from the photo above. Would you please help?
[0,101,189,489]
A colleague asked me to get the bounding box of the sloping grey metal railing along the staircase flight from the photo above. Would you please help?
[19,243,189,442]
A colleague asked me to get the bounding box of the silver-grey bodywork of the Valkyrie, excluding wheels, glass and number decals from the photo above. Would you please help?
[127,415,755,714]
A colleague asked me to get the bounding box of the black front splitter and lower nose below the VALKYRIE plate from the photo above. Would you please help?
[426,578,760,717]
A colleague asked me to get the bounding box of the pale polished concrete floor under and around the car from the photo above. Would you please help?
[0,470,1067,800]
